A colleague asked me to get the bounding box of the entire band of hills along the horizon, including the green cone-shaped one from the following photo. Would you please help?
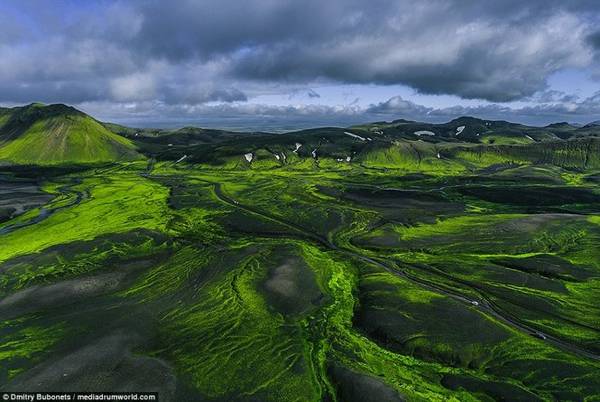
[0,103,600,167]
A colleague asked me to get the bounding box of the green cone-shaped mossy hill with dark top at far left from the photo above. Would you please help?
[0,103,141,165]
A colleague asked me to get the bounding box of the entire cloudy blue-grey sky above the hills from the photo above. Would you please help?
[0,0,600,129]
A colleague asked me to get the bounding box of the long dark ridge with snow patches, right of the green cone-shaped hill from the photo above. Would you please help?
[125,112,600,173]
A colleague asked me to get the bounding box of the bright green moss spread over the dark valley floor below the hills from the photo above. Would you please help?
[0,159,600,401]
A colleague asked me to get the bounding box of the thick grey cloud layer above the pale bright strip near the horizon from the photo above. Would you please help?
[0,0,600,105]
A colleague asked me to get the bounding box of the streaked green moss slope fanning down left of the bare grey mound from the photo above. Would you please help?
[157,247,318,400]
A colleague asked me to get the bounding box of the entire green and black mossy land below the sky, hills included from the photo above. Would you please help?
[0,105,600,401]
